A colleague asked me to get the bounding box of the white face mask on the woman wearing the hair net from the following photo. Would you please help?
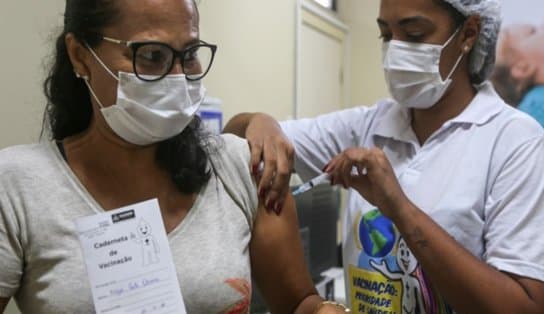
[383,29,463,109]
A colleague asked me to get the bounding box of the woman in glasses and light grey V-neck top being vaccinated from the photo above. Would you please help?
[0,0,344,314]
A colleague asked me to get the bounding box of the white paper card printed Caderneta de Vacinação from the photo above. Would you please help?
[76,199,186,314]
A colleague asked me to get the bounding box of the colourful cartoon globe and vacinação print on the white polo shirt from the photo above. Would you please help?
[347,204,453,314]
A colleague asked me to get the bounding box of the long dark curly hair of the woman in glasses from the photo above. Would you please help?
[42,0,211,193]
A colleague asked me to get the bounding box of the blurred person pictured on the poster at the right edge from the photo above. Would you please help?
[492,24,544,126]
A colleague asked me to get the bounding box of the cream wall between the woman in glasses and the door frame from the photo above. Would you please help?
[200,0,296,121]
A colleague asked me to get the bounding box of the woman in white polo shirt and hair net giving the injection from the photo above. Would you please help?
[225,0,544,314]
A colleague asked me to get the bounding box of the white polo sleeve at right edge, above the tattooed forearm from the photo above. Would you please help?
[484,136,544,281]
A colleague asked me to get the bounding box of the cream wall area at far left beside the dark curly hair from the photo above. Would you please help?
[0,0,64,148]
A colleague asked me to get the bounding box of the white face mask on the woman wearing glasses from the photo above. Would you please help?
[84,47,205,146]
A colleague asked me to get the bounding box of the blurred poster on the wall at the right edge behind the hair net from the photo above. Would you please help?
[492,0,544,126]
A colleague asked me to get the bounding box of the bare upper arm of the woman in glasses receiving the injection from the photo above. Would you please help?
[250,196,316,313]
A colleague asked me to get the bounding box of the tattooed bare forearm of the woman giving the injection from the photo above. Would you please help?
[391,203,542,314]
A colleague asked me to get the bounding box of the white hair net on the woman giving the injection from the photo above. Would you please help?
[443,0,502,81]
